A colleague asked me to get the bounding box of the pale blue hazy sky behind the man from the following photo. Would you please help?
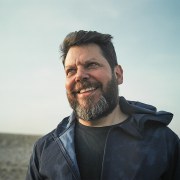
[0,0,180,136]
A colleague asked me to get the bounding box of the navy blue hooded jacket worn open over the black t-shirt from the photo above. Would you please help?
[26,97,180,180]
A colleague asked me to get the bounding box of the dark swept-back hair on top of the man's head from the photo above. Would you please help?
[60,30,118,69]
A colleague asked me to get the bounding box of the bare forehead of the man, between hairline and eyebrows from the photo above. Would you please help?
[65,44,108,67]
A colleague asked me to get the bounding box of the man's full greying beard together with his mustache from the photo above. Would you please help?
[67,74,119,121]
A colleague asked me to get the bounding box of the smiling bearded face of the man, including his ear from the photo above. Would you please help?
[65,44,122,120]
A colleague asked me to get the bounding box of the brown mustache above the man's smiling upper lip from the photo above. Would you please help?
[67,81,102,95]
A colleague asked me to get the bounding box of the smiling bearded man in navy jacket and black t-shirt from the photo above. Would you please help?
[26,30,180,180]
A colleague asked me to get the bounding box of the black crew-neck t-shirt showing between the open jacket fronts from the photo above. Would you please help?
[75,122,112,180]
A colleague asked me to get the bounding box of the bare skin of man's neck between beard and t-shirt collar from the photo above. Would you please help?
[79,104,128,127]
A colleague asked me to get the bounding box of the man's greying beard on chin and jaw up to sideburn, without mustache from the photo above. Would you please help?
[68,75,119,121]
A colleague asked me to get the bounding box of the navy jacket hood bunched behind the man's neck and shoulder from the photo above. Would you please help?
[119,96,173,128]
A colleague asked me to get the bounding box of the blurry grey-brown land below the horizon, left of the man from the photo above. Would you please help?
[0,133,40,180]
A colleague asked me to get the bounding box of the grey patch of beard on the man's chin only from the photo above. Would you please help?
[75,96,109,121]
